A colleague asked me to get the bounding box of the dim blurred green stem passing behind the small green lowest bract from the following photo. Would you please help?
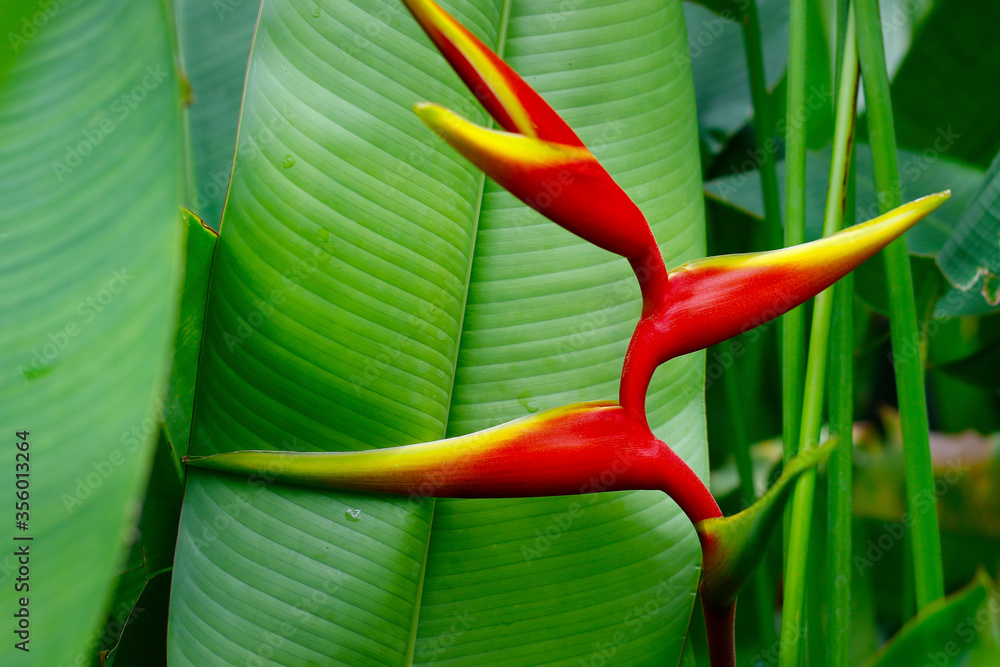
[723,366,778,646]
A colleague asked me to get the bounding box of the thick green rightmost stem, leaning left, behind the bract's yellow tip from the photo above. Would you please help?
[856,0,944,609]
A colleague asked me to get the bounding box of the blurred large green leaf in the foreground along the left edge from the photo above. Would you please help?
[0,0,181,665]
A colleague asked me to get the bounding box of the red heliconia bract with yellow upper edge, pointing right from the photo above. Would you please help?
[619,191,951,419]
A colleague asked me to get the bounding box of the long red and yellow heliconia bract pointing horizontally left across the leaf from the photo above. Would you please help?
[188,401,722,523]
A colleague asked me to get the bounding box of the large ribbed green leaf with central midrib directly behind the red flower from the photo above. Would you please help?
[170,0,707,665]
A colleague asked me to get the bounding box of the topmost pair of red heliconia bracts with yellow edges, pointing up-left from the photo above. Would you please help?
[403,0,666,301]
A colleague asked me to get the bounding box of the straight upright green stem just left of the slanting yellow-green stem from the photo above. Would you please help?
[781,0,808,561]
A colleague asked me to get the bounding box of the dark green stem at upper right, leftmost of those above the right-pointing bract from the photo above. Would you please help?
[743,0,784,249]
